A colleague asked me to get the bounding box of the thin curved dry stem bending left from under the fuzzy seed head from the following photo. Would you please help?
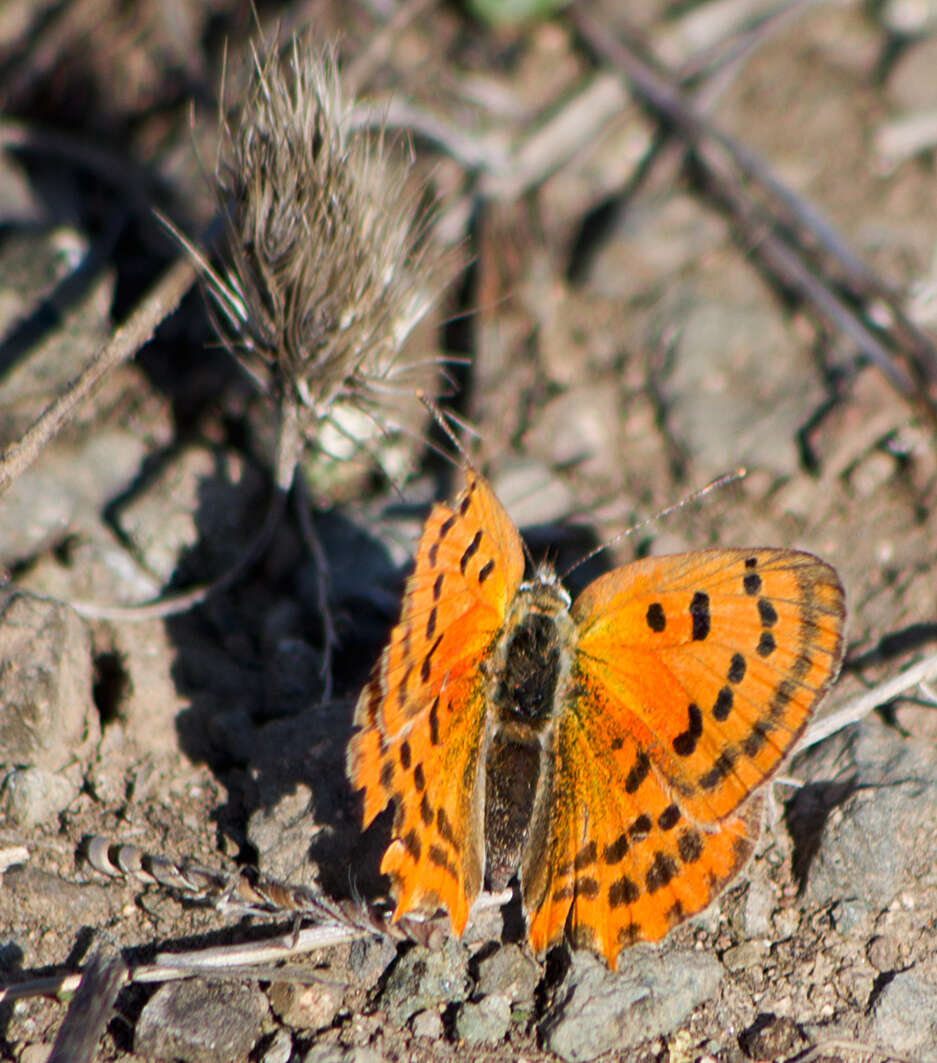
[69,406,304,620]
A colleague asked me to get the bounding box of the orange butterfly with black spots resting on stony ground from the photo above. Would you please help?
[347,466,844,968]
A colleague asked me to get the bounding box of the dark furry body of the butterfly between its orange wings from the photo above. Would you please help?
[485,569,575,890]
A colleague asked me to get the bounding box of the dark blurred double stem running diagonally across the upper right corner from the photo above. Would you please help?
[570,3,937,394]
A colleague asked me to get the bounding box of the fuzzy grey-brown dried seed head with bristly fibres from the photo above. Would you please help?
[212,38,449,433]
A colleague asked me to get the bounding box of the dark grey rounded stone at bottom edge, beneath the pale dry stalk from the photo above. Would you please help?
[133,978,268,1063]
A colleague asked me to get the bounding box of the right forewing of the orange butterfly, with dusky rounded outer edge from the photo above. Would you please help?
[572,550,844,821]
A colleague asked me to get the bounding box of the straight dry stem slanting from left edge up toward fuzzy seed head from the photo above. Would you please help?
[0,258,196,494]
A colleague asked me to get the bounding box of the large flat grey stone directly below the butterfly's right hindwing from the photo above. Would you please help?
[539,947,724,1063]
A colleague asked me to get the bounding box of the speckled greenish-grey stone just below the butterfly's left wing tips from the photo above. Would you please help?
[378,938,469,1027]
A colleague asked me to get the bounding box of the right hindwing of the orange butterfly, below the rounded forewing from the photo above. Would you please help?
[523,710,760,968]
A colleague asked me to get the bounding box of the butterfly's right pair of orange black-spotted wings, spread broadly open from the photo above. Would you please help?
[522,550,844,966]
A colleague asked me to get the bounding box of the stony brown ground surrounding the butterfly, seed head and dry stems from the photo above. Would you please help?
[0,0,937,1063]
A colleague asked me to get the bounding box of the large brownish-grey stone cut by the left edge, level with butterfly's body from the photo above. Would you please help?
[0,591,100,772]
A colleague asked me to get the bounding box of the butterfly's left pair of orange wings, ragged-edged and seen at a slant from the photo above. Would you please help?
[348,469,523,934]
